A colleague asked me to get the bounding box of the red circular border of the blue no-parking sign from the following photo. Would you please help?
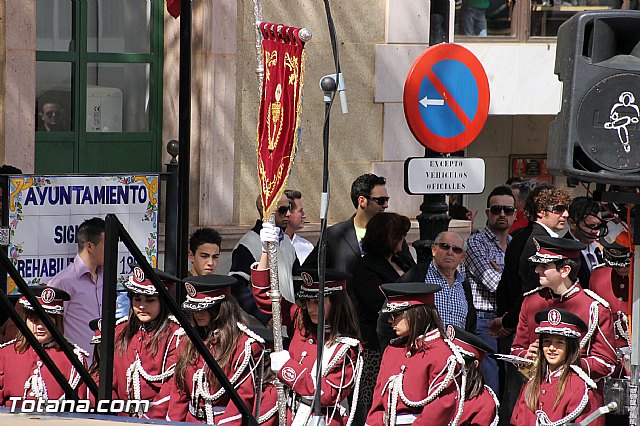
[402,43,490,153]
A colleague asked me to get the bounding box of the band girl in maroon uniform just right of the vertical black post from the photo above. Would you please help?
[113,266,184,419]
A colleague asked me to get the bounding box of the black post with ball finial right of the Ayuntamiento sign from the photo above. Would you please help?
[164,140,182,276]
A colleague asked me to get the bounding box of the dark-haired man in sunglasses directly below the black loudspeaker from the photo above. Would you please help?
[564,197,606,288]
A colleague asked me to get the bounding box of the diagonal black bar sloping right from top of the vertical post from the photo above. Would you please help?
[100,214,258,426]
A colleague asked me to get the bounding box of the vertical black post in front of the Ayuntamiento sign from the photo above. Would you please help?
[98,214,120,401]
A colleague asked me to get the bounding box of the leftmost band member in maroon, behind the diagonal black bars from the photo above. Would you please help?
[0,286,89,406]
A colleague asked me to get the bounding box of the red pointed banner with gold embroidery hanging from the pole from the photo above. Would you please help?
[256,22,306,220]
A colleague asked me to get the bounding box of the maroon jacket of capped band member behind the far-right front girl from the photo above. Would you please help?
[511,283,617,381]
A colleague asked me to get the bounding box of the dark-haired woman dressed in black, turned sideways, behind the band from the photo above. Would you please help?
[349,212,415,422]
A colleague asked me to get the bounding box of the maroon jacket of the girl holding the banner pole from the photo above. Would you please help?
[251,268,362,426]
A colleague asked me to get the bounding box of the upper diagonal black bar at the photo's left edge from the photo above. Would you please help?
[0,250,98,399]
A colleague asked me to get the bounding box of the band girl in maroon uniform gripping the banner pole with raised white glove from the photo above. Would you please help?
[251,228,362,426]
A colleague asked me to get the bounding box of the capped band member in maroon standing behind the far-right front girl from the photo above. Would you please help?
[511,237,616,405]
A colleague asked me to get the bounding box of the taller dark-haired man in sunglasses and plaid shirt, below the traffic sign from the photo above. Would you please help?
[465,186,516,394]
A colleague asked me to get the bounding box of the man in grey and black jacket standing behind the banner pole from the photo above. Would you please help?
[229,191,300,324]
